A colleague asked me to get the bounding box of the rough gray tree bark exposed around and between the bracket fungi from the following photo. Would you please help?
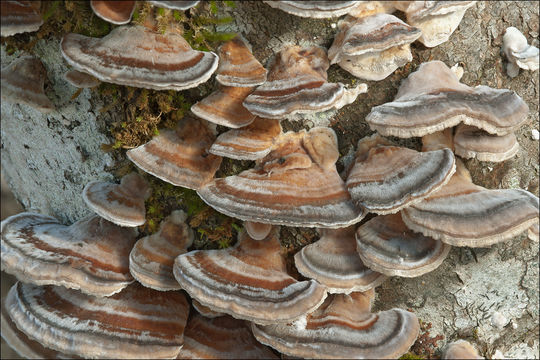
[1,2,539,358]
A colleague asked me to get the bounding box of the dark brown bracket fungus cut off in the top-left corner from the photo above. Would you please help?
[0,0,43,36]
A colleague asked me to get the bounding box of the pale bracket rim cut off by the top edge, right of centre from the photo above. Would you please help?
[265,0,362,19]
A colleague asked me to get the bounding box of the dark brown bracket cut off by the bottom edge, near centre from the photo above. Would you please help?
[177,314,278,359]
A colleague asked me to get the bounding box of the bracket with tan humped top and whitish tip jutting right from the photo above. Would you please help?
[244,45,367,119]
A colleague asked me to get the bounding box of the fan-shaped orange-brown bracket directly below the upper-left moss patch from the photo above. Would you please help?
[126,116,221,189]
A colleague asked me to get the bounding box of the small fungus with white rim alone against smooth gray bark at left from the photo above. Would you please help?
[83,172,151,227]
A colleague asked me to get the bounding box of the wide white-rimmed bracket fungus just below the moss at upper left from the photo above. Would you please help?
[60,25,218,91]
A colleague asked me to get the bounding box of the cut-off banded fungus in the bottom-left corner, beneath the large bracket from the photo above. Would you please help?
[0,299,73,359]
